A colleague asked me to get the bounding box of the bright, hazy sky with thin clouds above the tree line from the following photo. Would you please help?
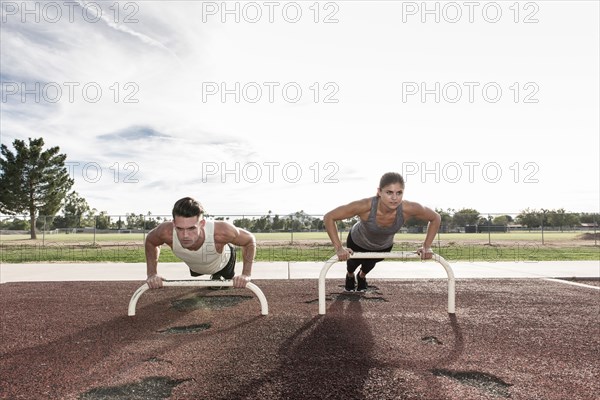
[0,0,600,219]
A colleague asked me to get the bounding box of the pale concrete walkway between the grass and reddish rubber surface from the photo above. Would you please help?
[0,261,600,283]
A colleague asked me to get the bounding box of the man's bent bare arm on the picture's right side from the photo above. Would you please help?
[215,221,256,288]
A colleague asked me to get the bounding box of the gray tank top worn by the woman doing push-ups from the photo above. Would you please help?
[350,196,404,250]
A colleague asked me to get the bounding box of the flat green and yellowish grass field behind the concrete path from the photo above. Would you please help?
[0,232,600,263]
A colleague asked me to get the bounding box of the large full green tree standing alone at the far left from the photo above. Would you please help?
[0,138,74,239]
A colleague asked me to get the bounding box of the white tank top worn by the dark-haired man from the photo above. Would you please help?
[173,221,231,275]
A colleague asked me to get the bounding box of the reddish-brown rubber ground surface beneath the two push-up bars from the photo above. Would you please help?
[0,280,600,400]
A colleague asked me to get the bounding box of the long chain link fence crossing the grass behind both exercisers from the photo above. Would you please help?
[0,212,600,245]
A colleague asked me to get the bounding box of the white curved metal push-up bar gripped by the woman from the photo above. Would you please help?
[319,251,455,315]
